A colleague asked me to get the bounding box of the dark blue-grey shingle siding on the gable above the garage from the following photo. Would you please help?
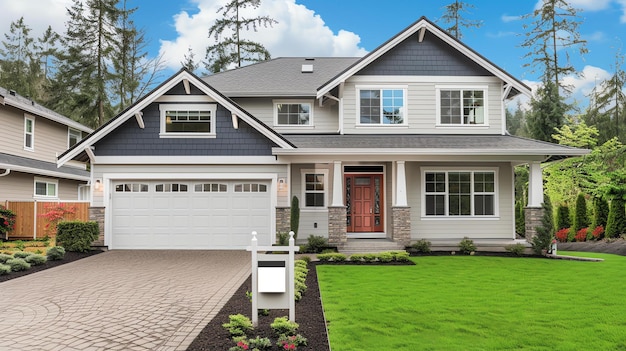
[95,103,275,156]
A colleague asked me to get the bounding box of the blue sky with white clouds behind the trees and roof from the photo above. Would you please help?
[0,0,626,107]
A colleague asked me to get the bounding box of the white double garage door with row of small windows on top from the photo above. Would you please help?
[110,180,271,249]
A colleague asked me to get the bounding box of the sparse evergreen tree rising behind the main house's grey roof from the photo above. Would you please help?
[205,0,278,73]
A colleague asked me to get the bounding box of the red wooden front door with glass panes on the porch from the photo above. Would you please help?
[344,174,384,233]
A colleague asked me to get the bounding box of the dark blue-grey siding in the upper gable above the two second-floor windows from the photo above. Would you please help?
[356,32,492,76]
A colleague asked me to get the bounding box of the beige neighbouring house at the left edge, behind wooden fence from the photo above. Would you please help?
[0,88,93,204]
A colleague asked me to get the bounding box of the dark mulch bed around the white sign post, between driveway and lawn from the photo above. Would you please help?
[187,262,330,351]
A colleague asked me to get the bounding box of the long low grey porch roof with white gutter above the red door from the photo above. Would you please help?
[274,134,589,157]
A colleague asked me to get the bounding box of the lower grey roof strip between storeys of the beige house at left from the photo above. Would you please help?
[0,153,89,180]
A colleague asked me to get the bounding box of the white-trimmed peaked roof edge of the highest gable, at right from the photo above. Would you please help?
[317,17,532,98]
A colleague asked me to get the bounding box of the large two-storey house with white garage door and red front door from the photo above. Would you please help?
[58,18,586,249]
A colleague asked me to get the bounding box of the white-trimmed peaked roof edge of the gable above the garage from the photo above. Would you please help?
[57,68,294,167]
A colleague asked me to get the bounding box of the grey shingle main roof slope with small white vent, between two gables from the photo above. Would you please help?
[202,57,359,97]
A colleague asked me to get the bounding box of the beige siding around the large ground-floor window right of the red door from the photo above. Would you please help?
[406,162,515,241]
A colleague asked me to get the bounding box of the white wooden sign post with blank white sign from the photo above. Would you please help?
[248,232,300,327]
